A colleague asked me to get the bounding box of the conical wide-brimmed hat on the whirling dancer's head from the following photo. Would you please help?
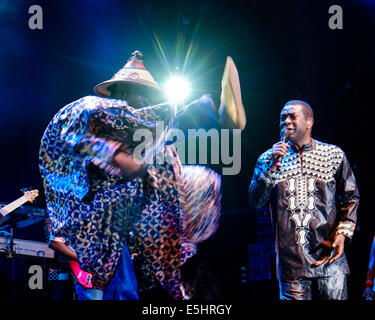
[94,51,162,97]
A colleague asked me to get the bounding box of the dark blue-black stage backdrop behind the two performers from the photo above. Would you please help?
[0,0,375,300]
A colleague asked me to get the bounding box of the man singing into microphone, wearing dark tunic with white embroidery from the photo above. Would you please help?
[249,100,359,300]
